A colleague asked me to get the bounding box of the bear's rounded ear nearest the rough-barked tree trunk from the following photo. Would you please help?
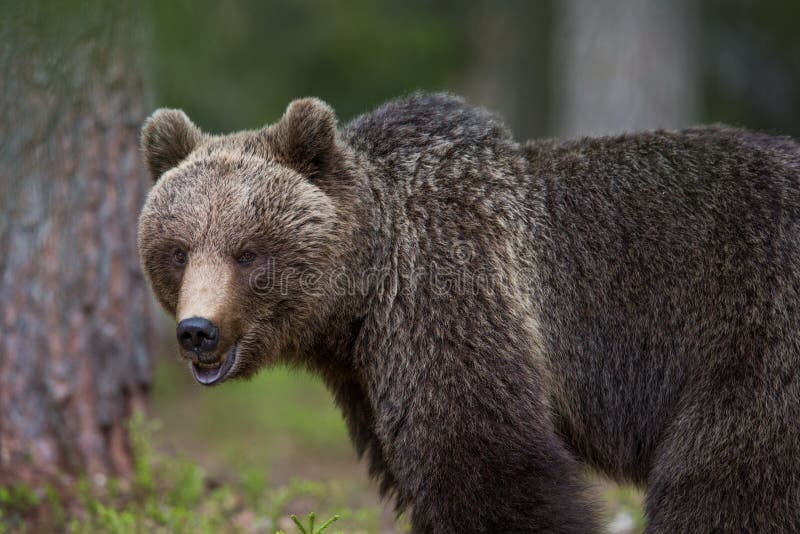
[141,108,203,182]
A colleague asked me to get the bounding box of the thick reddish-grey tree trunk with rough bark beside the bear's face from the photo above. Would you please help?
[0,1,152,485]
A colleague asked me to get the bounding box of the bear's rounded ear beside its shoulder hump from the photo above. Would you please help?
[265,98,336,178]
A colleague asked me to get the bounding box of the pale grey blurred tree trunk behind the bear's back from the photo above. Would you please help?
[554,0,697,137]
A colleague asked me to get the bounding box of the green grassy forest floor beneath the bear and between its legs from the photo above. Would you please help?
[0,358,643,534]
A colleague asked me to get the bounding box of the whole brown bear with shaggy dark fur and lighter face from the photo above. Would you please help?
[139,95,800,533]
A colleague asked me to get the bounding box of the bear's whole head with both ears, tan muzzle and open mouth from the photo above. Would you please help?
[138,98,355,385]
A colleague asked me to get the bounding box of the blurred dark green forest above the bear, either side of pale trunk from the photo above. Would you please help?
[148,0,800,137]
